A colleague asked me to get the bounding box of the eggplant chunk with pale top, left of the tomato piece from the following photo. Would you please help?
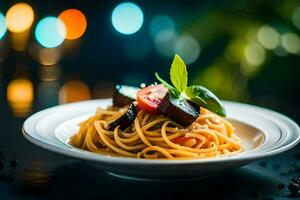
[113,85,140,107]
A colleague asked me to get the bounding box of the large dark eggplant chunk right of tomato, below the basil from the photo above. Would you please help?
[158,92,200,126]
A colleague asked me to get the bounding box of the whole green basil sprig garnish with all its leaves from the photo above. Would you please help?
[155,54,226,116]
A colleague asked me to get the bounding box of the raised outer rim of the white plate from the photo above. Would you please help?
[22,98,300,165]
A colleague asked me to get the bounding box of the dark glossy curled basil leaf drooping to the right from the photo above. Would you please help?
[185,85,226,117]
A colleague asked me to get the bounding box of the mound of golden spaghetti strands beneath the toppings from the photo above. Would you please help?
[70,107,243,159]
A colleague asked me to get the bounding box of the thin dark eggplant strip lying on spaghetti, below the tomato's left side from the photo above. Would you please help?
[108,103,138,131]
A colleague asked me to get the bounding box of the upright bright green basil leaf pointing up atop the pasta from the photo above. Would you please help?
[170,54,188,92]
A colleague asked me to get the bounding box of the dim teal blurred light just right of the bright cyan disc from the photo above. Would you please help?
[150,15,175,42]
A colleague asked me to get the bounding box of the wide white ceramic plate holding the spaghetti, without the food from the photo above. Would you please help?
[23,99,300,181]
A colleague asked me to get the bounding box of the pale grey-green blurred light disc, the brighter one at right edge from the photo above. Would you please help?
[281,33,300,54]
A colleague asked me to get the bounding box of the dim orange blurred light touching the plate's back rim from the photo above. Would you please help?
[59,80,91,104]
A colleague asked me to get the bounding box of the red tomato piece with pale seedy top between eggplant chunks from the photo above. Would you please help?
[137,84,168,114]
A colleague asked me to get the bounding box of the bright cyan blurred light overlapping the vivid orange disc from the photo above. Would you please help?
[35,17,66,48]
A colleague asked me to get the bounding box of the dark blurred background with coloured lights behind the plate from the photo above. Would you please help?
[0,0,300,124]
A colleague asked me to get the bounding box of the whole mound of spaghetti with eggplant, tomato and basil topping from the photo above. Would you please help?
[69,55,244,159]
